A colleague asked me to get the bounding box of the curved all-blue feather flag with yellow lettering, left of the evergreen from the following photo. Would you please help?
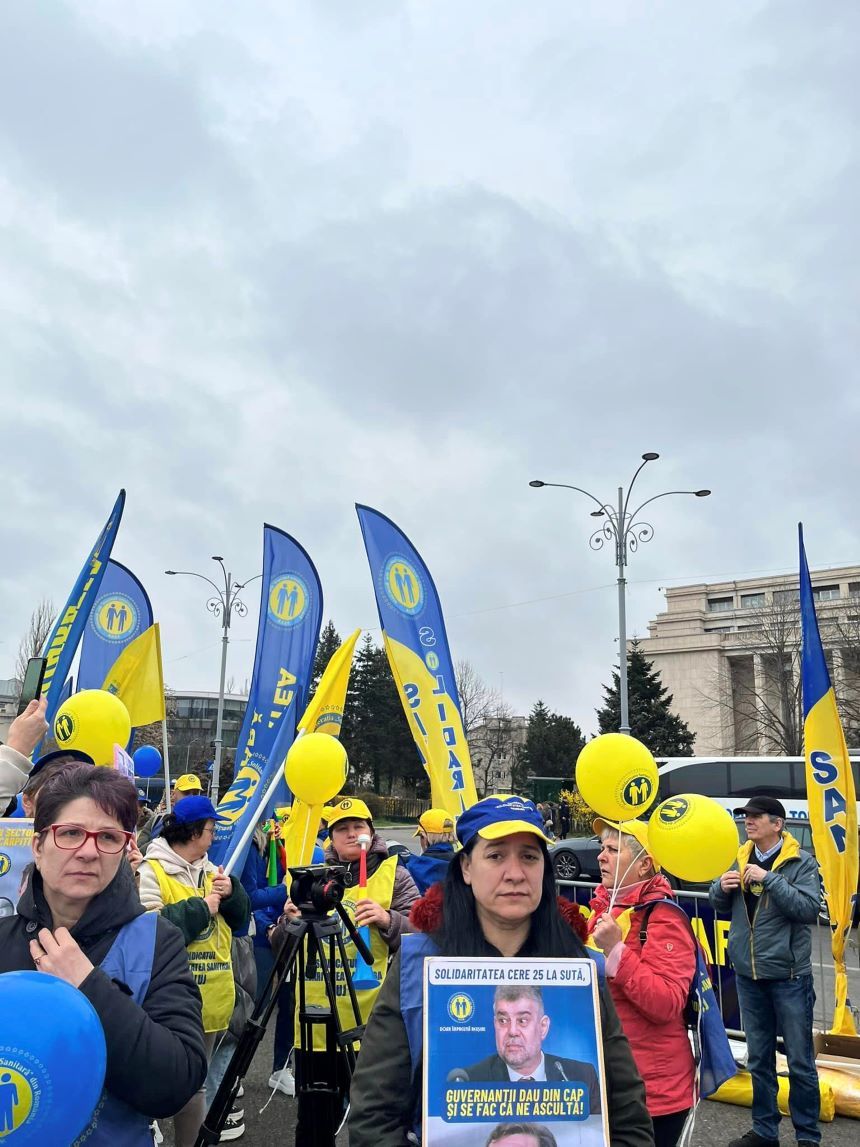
[209,525,322,872]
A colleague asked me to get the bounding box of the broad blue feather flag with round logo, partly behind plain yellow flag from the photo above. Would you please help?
[77,557,153,690]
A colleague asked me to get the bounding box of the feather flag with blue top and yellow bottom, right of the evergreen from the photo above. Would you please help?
[355,506,478,817]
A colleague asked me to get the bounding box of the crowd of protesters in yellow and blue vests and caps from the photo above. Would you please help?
[0,702,834,1147]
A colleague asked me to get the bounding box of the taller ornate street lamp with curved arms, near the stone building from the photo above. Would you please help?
[529,451,711,735]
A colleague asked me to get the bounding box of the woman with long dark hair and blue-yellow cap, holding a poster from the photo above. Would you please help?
[349,796,654,1147]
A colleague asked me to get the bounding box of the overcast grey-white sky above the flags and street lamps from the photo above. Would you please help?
[0,0,860,732]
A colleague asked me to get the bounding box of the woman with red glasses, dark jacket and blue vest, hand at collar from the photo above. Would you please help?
[0,765,206,1147]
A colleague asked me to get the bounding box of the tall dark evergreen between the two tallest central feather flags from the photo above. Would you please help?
[341,633,429,796]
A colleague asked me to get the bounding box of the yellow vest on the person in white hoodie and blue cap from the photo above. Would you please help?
[148,858,236,1031]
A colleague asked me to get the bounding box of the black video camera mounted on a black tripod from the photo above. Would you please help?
[195,866,373,1147]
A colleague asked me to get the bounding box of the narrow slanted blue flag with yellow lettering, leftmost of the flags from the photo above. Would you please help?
[41,490,125,725]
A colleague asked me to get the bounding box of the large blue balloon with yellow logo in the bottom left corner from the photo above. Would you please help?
[0,972,107,1147]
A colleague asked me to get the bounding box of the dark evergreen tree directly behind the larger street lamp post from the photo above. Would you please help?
[597,641,696,757]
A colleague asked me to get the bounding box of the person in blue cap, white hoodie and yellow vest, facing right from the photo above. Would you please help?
[138,796,251,1147]
